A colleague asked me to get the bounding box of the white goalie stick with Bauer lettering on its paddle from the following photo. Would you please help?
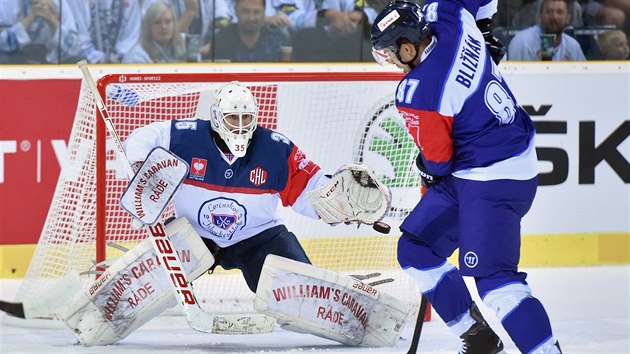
[77,60,215,333]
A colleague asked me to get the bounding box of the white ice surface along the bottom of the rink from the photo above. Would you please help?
[0,265,630,354]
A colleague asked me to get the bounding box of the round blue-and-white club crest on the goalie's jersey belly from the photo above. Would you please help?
[197,197,247,240]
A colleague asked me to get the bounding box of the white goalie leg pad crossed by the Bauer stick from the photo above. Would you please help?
[57,218,214,346]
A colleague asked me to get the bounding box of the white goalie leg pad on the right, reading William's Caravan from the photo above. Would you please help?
[254,255,412,346]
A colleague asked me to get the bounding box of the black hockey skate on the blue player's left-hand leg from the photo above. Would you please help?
[459,302,504,354]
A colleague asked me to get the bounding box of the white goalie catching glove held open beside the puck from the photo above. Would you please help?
[307,164,391,225]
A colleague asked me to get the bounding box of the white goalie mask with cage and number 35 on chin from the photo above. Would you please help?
[210,81,258,157]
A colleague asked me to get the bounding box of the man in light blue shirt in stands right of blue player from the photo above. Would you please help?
[508,0,586,61]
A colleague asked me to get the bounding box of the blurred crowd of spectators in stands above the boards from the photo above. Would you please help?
[0,0,630,64]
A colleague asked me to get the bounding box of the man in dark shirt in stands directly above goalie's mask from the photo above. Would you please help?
[211,0,291,62]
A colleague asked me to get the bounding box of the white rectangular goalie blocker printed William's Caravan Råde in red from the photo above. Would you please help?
[120,147,189,225]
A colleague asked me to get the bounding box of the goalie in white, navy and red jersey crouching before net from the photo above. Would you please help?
[37,82,411,346]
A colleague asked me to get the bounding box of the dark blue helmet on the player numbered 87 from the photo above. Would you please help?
[371,0,429,62]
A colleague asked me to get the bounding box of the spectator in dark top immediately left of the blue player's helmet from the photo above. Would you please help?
[294,0,376,61]
